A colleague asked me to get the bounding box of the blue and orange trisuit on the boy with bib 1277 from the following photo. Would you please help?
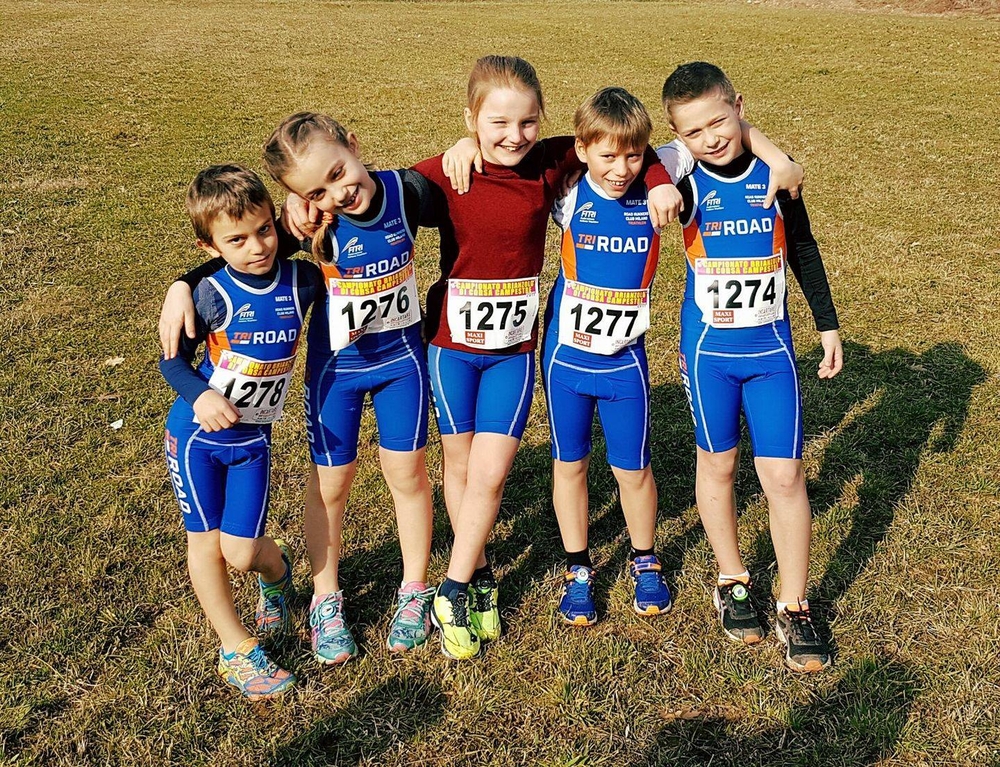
[542,174,660,470]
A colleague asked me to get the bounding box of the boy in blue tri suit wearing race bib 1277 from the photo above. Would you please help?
[542,88,671,626]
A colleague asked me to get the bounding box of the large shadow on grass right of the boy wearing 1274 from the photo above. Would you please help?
[748,343,985,617]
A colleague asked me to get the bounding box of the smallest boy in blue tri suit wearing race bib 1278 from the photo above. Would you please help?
[160,165,321,699]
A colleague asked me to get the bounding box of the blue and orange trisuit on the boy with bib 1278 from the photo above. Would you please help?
[161,261,320,538]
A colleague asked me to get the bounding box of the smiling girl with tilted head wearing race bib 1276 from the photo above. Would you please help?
[161,112,433,665]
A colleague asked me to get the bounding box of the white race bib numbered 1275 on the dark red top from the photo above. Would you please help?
[448,277,538,349]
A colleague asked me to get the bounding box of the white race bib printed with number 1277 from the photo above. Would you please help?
[559,280,649,354]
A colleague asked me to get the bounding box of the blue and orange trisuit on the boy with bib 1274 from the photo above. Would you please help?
[679,157,803,458]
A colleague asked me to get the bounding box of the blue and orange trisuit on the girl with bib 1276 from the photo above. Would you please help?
[306,171,429,466]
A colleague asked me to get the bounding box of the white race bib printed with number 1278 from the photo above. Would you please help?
[205,349,295,424]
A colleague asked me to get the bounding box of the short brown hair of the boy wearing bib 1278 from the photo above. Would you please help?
[185,163,274,244]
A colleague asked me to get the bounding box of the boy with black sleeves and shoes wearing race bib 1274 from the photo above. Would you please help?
[663,62,843,671]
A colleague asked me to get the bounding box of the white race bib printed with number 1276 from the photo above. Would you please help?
[327,262,420,352]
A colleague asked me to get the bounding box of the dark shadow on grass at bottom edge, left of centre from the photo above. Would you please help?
[265,676,447,767]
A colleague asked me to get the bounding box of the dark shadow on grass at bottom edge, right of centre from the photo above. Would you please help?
[630,656,920,767]
